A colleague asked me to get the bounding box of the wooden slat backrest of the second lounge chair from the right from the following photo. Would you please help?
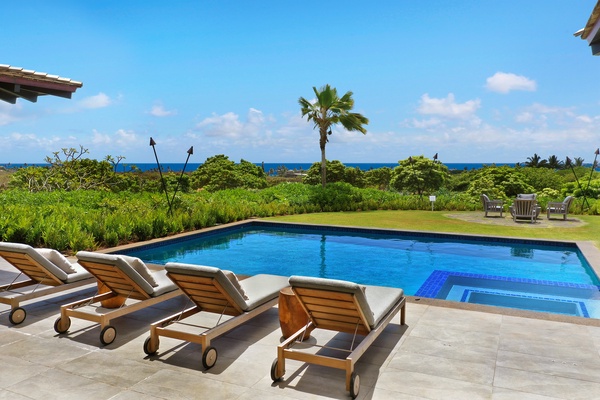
[167,272,244,316]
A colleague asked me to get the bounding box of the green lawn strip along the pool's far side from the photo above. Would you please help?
[265,211,600,248]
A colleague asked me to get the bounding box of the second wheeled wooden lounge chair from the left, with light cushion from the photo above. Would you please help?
[54,251,182,345]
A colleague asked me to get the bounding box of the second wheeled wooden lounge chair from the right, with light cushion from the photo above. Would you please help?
[144,263,288,369]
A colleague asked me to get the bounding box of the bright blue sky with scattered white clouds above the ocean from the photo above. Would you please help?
[0,0,600,163]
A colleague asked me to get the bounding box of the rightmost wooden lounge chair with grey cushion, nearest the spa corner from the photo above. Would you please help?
[271,276,406,398]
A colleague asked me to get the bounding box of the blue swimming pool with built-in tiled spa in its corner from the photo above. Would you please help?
[122,221,600,318]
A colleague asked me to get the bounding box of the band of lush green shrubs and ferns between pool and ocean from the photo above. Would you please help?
[0,149,600,251]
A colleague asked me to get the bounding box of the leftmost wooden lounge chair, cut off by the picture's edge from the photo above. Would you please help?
[0,242,95,325]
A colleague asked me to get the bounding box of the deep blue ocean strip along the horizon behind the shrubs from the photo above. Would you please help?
[0,162,599,175]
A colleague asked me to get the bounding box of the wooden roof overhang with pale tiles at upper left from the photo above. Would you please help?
[0,64,83,104]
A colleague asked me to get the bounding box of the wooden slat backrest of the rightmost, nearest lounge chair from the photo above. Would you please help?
[292,287,371,335]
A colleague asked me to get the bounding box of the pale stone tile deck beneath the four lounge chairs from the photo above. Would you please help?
[0,255,600,400]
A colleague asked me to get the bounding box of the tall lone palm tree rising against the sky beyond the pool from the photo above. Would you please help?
[298,84,369,187]
